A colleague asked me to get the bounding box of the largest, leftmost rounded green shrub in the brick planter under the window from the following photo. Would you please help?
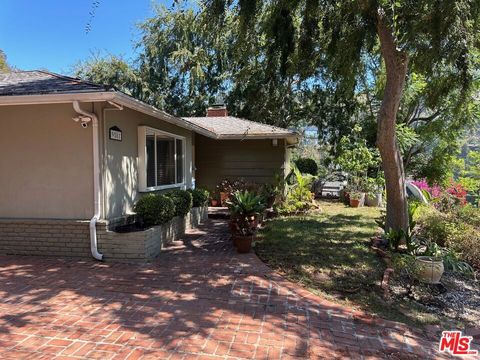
[134,194,175,226]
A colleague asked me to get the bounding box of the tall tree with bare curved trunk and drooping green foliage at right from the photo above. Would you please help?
[204,0,480,229]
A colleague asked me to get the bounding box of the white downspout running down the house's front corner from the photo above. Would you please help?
[73,101,103,260]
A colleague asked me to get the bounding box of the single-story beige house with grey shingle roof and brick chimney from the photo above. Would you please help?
[0,71,298,259]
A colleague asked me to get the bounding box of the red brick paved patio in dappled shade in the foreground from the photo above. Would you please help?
[0,220,474,359]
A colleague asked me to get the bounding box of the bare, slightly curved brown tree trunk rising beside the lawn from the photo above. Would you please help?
[377,9,408,231]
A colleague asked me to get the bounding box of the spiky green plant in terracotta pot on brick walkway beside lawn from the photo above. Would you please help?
[227,190,265,253]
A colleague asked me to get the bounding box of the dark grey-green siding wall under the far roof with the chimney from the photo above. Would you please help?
[195,134,286,191]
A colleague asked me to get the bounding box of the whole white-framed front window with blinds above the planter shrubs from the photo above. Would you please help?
[138,126,185,191]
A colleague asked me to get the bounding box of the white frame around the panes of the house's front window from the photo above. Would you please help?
[138,126,187,192]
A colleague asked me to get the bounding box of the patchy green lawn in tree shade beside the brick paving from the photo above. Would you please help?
[255,201,436,325]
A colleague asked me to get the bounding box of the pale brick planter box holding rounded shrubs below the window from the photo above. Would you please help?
[98,207,208,262]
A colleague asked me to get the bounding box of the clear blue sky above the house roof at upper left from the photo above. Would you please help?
[0,0,171,75]
